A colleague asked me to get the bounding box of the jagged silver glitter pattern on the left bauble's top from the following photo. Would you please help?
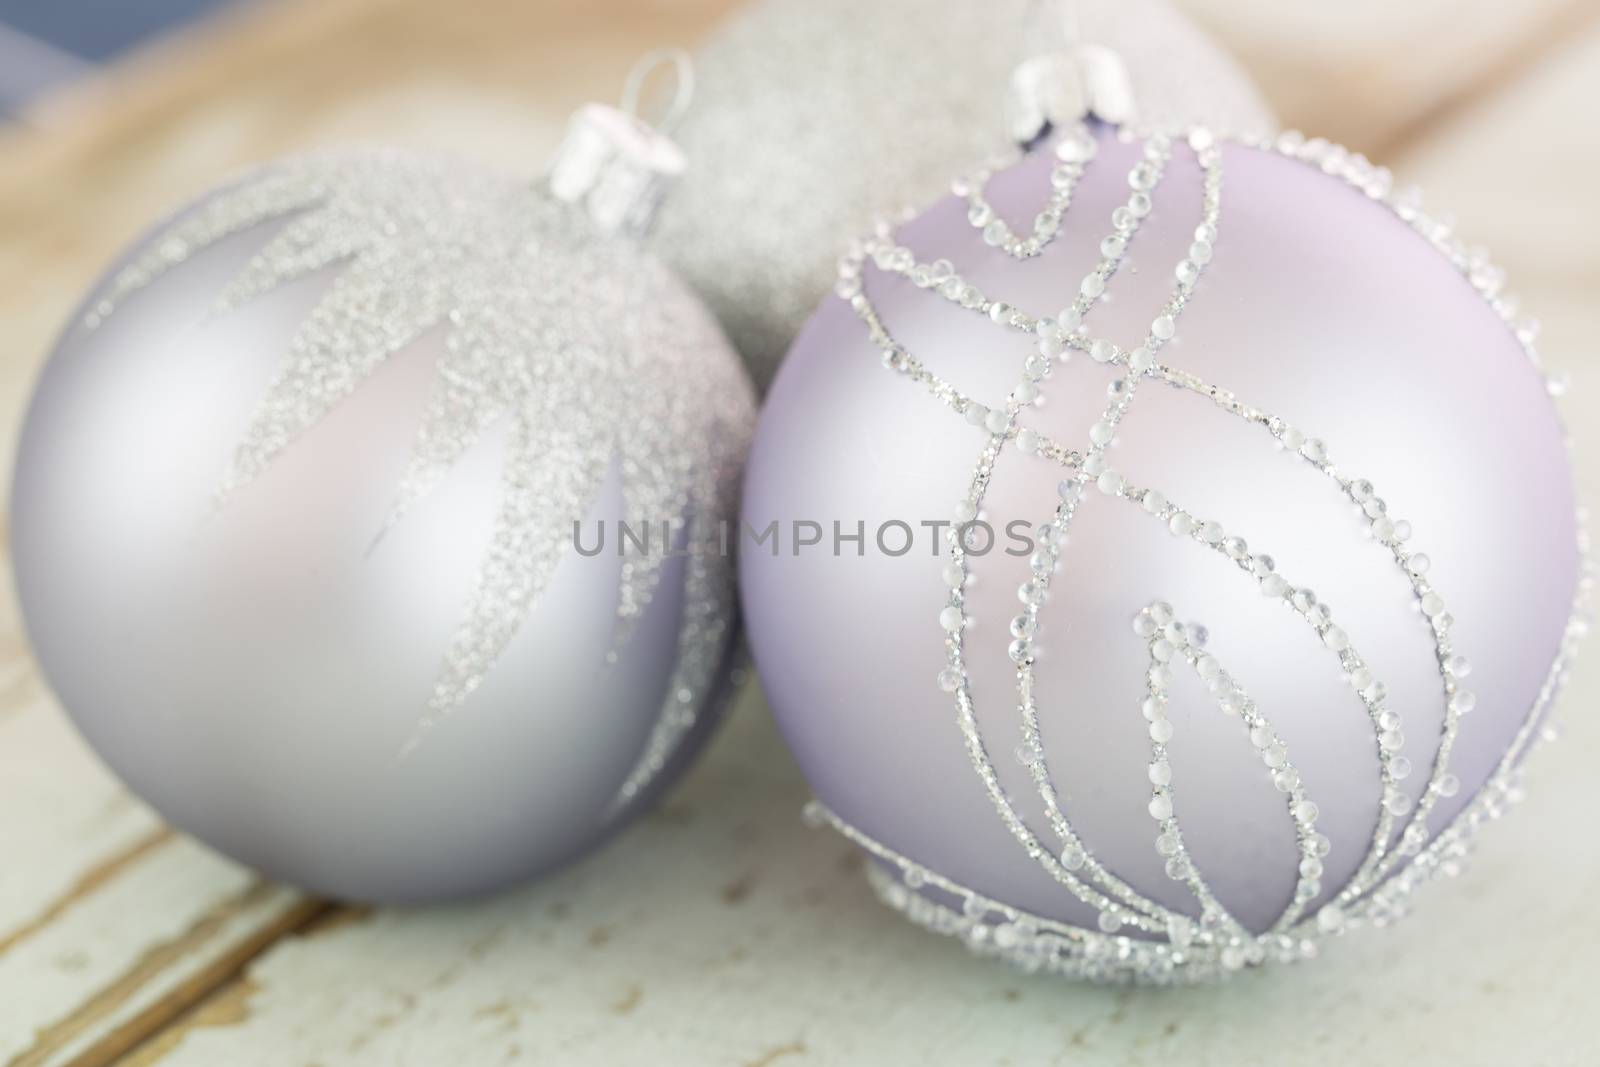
[86,150,752,805]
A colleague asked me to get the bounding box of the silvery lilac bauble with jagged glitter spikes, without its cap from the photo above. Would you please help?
[11,150,754,901]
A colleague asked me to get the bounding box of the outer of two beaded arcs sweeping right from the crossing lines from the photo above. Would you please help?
[1152,366,1477,904]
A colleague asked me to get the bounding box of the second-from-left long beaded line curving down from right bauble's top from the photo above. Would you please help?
[1008,136,1222,931]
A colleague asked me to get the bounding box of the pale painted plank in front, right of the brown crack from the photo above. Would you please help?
[118,684,1600,1067]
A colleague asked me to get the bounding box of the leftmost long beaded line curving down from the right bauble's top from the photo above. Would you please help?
[939,138,1190,933]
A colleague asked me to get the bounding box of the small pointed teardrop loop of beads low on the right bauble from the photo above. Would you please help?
[1133,601,1330,947]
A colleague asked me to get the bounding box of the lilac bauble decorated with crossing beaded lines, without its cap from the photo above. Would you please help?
[741,126,1587,981]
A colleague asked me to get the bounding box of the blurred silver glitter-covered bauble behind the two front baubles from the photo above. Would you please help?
[658,0,1274,389]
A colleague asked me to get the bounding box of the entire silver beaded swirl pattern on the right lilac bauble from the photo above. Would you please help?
[808,125,1592,982]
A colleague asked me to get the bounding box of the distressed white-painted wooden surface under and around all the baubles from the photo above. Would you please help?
[0,0,1600,1067]
